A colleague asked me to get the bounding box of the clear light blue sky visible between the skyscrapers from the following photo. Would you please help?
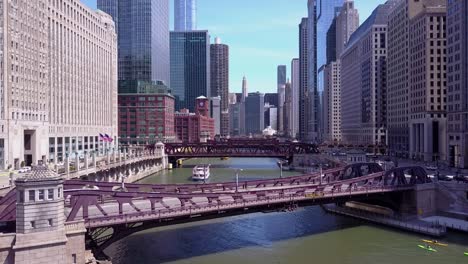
[81,0,385,92]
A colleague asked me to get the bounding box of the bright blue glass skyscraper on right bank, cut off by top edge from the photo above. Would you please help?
[309,0,344,141]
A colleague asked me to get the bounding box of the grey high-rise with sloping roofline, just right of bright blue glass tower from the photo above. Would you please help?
[341,1,392,145]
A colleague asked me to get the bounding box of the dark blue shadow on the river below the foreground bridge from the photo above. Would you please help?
[107,207,359,264]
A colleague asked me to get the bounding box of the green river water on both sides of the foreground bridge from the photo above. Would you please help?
[106,159,468,264]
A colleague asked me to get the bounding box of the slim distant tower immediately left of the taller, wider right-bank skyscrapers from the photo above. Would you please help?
[290,58,300,138]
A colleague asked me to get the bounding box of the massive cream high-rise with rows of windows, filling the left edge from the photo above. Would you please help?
[0,0,117,169]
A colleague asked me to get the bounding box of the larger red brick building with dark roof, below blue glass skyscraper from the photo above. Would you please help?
[119,81,175,145]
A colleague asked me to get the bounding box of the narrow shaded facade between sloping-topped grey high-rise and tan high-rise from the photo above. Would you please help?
[387,0,410,157]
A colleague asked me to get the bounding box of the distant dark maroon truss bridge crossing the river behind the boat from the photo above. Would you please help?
[165,139,320,159]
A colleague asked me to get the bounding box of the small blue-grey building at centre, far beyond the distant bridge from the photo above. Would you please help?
[245,92,265,135]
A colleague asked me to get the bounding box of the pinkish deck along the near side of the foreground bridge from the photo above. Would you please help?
[75,186,413,228]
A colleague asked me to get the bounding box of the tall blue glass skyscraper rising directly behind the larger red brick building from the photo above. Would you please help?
[97,0,170,86]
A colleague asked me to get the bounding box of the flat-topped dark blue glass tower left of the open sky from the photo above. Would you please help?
[170,30,211,112]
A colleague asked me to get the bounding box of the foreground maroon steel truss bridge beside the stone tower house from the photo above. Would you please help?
[0,163,431,256]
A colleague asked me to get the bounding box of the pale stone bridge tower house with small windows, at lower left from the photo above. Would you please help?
[13,166,86,264]
